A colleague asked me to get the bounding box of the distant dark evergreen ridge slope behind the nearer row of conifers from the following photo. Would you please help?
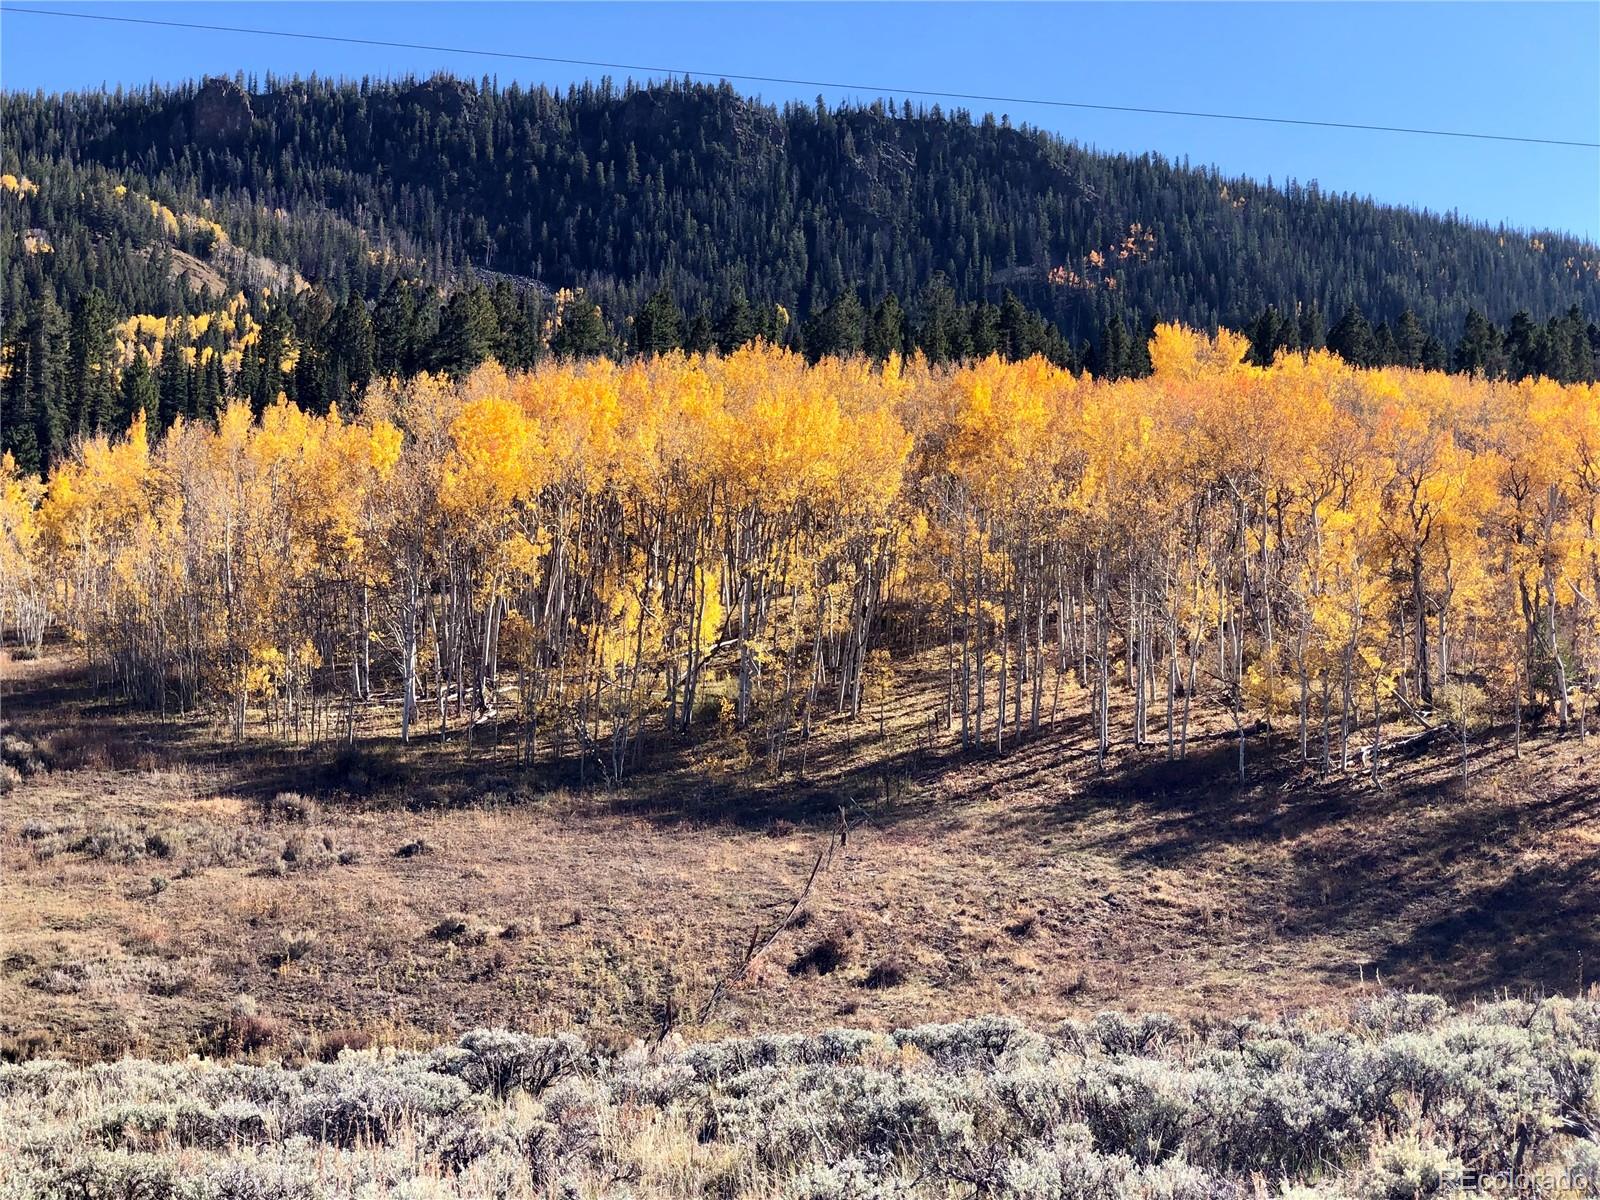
[3,78,1600,342]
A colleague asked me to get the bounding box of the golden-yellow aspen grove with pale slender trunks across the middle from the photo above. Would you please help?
[0,325,1600,779]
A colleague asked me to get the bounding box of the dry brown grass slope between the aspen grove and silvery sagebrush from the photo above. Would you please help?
[0,650,1600,1061]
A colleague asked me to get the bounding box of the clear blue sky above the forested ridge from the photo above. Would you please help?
[0,0,1600,238]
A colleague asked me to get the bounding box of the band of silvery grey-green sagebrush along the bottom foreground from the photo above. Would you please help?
[0,995,1600,1200]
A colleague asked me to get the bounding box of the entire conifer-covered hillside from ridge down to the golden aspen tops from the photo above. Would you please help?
[0,71,1600,472]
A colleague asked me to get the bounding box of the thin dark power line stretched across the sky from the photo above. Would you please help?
[0,5,1600,150]
